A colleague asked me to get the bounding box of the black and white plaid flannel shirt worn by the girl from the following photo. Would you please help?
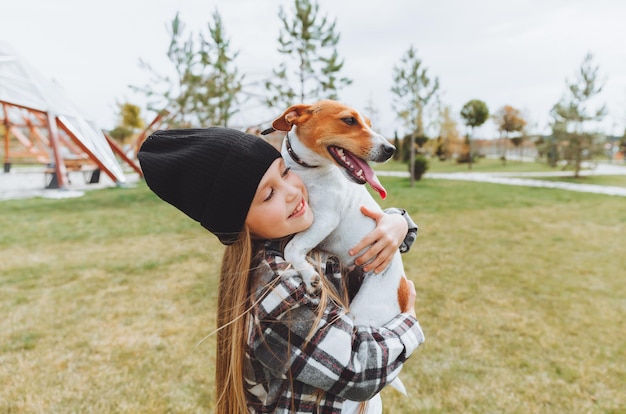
[244,241,424,413]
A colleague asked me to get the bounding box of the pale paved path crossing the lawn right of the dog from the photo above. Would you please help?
[376,164,626,197]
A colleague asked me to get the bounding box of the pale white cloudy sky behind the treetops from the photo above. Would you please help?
[0,0,626,137]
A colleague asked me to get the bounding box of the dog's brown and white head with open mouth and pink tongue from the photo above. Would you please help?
[272,100,396,199]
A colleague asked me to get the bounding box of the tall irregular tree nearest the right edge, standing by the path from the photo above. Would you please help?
[550,53,606,178]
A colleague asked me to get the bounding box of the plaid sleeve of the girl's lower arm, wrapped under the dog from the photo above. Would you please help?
[249,269,424,401]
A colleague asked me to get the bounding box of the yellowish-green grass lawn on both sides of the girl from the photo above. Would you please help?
[0,177,626,413]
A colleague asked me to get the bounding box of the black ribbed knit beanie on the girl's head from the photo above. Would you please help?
[137,127,280,245]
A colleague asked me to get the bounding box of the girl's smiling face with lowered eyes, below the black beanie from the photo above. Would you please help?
[246,157,313,243]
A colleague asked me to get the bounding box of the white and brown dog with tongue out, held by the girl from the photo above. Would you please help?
[264,100,409,394]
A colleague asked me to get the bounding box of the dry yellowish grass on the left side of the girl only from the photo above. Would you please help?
[0,189,221,413]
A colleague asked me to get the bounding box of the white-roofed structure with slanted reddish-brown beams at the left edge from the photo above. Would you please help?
[0,42,142,189]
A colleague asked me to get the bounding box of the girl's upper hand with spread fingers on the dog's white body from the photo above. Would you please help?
[349,206,408,273]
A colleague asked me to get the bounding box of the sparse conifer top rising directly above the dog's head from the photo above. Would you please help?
[265,0,352,108]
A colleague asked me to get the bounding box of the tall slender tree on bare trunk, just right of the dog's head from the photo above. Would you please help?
[391,45,439,187]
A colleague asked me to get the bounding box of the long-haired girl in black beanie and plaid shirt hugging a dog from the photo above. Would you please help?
[138,128,424,414]
